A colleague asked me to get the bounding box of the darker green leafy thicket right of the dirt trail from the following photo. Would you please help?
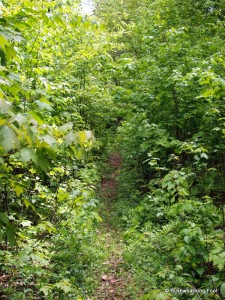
[94,0,225,299]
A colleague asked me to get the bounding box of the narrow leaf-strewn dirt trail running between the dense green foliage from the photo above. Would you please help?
[94,153,132,300]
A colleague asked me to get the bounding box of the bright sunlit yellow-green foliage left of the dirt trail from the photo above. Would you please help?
[0,0,114,299]
